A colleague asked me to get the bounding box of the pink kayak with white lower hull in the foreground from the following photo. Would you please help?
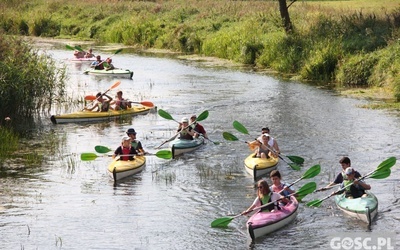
[247,196,299,242]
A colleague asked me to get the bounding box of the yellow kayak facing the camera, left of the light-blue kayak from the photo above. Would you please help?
[107,156,146,181]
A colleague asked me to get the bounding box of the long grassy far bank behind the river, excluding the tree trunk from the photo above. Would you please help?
[0,0,400,101]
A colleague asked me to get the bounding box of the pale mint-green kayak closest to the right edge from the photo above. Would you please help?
[335,191,378,225]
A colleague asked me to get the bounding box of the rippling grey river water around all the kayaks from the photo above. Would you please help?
[0,42,400,249]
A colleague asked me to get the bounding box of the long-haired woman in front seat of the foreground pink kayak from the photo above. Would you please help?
[241,180,281,215]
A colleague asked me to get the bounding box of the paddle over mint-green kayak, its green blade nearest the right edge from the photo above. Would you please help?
[306,157,396,207]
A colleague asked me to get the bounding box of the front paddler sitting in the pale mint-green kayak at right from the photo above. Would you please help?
[341,167,371,199]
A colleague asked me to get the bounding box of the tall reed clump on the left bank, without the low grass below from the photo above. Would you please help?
[0,33,66,131]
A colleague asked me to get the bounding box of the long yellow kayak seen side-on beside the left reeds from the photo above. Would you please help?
[50,105,154,124]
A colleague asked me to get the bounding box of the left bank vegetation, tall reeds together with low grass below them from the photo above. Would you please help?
[0,31,66,167]
